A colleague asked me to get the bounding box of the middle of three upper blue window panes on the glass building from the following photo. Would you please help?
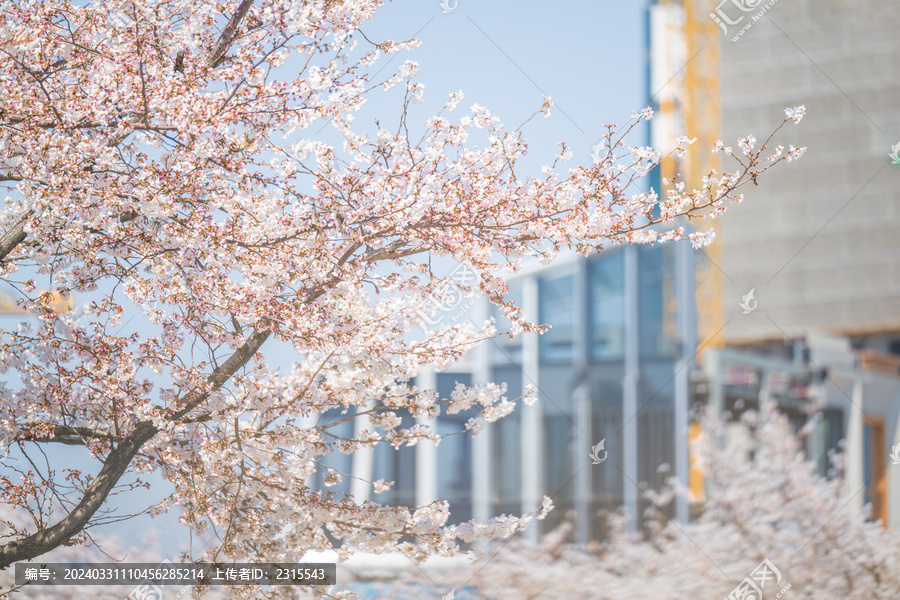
[588,250,625,361]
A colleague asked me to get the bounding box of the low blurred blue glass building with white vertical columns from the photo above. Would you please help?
[319,242,696,542]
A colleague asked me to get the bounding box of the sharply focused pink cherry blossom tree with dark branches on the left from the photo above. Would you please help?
[0,0,803,592]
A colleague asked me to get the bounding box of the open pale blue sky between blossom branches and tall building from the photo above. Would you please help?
[350,0,647,163]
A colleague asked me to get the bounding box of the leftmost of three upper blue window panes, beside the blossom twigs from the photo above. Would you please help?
[538,269,575,363]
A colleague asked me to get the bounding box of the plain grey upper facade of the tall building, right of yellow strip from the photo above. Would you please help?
[712,0,900,342]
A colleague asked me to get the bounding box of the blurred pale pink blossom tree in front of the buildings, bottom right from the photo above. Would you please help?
[370,402,900,600]
